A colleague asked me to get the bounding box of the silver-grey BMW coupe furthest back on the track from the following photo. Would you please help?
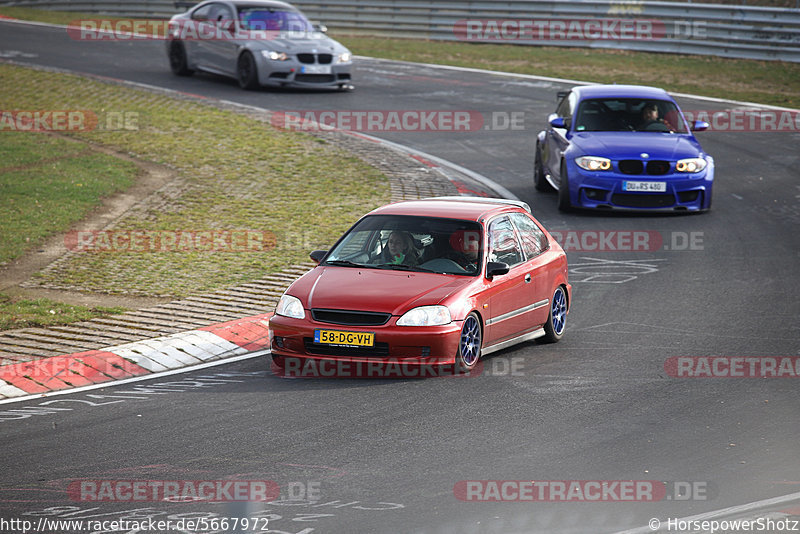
[166,0,353,89]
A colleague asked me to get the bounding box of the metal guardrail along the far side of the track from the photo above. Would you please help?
[6,0,800,63]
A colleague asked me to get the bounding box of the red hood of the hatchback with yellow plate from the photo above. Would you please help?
[289,266,474,315]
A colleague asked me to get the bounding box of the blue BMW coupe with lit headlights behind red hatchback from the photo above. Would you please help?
[533,85,714,211]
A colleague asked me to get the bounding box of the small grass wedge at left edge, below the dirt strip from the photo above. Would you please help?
[0,294,124,330]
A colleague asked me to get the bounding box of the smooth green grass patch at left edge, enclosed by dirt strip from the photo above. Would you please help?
[0,134,137,264]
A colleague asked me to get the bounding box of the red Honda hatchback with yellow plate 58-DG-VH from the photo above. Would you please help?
[269,197,572,371]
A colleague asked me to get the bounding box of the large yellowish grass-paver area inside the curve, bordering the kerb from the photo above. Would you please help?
[0,65,390,297]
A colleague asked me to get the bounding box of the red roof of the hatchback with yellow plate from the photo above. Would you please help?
[370,197,530,221]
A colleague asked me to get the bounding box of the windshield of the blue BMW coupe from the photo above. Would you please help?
[574,98,687,133]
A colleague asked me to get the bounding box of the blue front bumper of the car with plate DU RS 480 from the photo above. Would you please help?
[567,158,714,211]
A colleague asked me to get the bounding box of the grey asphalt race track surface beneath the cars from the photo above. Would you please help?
[0,19,800,534]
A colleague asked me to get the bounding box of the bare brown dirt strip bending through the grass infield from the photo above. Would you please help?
[0,133,177,308]
